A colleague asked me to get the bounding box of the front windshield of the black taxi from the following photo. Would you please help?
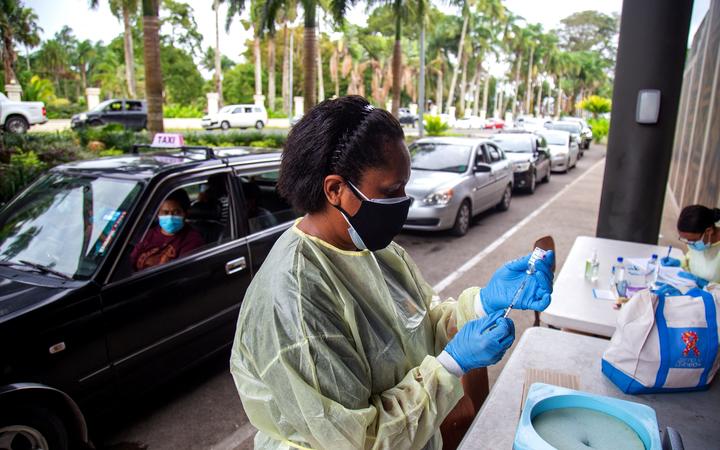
[0,172,141,280]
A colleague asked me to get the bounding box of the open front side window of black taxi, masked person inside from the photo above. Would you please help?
[114,174,233,279]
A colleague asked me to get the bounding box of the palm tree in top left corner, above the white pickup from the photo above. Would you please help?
[0,0,42,84]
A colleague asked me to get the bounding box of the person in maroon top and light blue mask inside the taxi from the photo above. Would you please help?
[130,189,205,271]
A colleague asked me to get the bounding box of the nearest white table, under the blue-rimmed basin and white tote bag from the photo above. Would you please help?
[458,327,720,450]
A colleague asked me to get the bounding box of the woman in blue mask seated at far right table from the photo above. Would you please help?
[660,205,720,287]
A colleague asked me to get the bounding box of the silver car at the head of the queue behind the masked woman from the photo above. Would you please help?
[405,137,513,236]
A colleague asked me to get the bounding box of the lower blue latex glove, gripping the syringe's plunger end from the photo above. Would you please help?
[445,311,515,372]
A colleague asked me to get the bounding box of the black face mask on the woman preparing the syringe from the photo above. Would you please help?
[333,181,412,252]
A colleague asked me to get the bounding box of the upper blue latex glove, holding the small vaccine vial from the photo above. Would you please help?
[480,250,555,314]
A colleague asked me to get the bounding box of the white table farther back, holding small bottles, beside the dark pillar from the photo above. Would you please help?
[540,236,683,337]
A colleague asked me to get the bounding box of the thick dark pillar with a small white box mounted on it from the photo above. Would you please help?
[597,0,693,244]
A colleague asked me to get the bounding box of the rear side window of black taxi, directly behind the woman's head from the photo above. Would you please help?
[238,170,299,234]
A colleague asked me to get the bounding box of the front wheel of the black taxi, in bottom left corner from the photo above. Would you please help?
[0,406,69,450]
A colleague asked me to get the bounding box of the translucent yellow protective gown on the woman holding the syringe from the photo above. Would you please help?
[230,226,483,450]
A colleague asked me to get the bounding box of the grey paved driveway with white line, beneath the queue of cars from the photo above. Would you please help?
[95,146,677,450]
